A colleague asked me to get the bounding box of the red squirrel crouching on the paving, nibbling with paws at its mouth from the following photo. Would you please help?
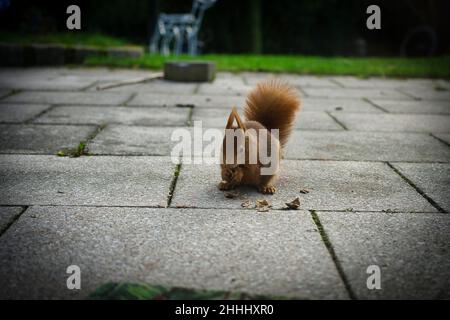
[219,80,300,194]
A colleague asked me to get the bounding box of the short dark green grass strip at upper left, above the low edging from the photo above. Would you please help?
[0,32,131,47]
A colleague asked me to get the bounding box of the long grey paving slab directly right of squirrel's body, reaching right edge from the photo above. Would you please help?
[285,131,450,162]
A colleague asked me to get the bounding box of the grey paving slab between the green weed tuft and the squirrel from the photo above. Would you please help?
[87,125,192,156]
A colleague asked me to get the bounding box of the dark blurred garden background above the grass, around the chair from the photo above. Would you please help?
[0,0,450,56]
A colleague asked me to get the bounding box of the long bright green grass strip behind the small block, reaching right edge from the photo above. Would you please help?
[86,54,450,78]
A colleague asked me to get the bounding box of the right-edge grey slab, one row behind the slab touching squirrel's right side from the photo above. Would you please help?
[332,112,450,133]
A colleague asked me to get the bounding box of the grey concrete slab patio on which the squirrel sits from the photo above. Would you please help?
[0,68,450,299]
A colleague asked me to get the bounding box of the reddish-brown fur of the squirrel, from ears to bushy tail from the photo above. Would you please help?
[219,80,300,194]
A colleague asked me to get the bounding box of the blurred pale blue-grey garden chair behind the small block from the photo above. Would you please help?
[149,0,217,56]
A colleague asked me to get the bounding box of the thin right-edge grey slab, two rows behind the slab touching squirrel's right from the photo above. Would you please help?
[370,99,450,114]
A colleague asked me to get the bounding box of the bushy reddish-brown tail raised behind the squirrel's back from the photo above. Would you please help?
[244,80,300,146]
